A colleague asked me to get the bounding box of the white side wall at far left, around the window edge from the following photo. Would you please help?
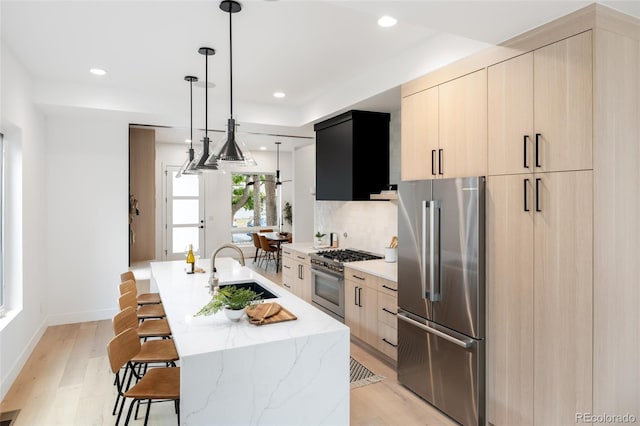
[0,44,49,397]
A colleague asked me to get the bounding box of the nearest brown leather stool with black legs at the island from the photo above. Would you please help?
[107,328,180,426]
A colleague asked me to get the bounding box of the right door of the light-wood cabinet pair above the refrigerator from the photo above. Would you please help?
[438,69,487,177]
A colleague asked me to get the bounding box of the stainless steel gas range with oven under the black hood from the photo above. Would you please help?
[309,249,382,322]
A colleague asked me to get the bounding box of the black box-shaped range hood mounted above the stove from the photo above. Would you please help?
[314,110,390,201]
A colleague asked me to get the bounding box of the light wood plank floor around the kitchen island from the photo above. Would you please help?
[0,261,455,426]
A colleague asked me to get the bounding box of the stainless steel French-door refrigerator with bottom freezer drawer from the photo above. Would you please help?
[398,176,485,425]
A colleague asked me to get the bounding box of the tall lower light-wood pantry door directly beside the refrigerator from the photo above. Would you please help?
[486,175,535,426]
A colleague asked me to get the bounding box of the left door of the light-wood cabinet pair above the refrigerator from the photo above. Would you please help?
[400,87,438,180]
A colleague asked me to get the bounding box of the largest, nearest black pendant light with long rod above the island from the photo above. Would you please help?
[205,0,257,166]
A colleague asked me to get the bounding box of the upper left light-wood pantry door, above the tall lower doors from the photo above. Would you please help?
[487,52,534,175]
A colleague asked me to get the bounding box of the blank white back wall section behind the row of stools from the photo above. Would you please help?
[43,116,129,324]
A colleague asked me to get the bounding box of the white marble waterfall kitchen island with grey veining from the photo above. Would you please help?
[151,258,350,425]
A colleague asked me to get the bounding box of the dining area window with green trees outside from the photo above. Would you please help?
[231,173,278,244]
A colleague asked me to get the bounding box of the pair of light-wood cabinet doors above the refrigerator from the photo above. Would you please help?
[401,69,487,180]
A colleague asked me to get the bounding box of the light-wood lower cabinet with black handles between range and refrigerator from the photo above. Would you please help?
[344,268,398,360]
